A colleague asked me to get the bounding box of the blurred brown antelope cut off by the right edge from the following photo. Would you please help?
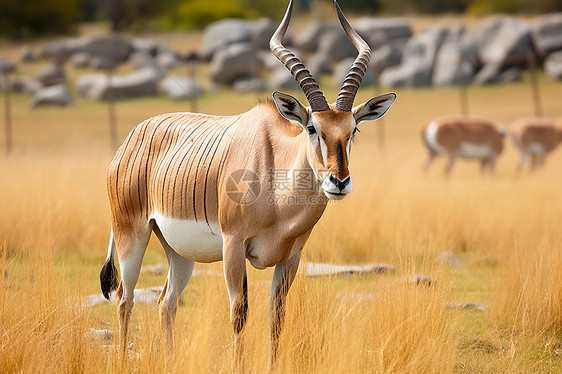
[511,118,562,172]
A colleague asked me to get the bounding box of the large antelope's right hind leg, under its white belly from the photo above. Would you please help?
[154,227,195,353]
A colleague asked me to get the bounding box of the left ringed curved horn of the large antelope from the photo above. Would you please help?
[269,0,330,112]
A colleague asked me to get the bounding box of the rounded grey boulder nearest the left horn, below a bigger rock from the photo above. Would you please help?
[210,43,258,84]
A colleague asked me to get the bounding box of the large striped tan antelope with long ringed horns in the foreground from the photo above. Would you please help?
[100,0,396,367]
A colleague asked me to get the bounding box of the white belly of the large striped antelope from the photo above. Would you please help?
[150,213,222,262]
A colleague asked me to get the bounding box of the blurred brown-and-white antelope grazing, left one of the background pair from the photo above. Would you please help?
[422,116,505,175]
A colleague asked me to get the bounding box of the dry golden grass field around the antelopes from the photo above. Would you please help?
[0,58,562,373]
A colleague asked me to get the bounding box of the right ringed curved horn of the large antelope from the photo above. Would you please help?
[334,0,371,112]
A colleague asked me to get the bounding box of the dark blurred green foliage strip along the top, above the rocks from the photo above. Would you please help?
[0,0,562,39]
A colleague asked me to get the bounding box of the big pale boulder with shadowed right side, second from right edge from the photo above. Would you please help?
[469,16,533,69]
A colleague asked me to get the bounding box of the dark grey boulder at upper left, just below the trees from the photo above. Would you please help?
[78,33,133,64]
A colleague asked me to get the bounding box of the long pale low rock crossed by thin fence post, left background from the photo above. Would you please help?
[76,69,160,99]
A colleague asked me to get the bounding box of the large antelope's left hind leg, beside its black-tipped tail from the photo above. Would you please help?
[114,230,151,354]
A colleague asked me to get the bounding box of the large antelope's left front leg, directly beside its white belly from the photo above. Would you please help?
[223,238,248,372]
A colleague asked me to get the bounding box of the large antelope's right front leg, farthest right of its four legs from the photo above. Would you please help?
[269,250,302,371]
